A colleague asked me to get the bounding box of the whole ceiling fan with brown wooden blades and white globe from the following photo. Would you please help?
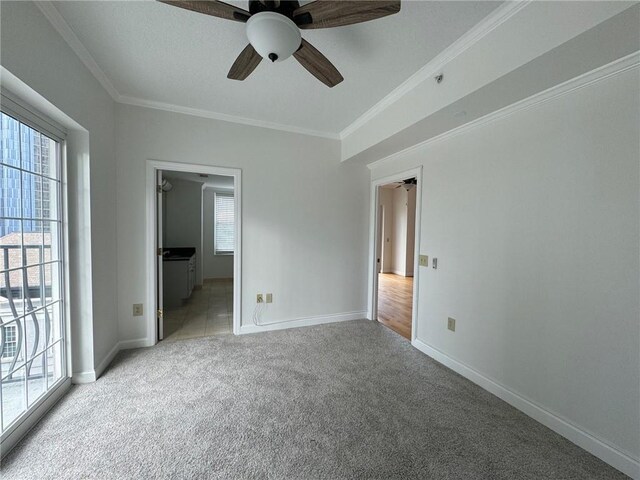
[159,0,400,87]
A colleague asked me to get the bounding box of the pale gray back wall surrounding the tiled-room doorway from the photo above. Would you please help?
[116,105,369,340]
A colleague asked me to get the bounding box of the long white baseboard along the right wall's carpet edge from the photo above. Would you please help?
[412,339,640,479]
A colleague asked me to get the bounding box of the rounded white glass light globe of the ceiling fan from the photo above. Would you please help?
[247,12,301,62]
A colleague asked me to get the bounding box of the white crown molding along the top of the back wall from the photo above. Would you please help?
[118,95,340,140]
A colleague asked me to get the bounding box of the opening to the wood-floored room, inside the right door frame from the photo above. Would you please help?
[375,177,417,340]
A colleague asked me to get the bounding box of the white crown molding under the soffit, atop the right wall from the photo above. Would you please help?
[367,51,640,170]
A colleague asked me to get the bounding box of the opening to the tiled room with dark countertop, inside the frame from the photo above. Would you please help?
[158,170,235,341]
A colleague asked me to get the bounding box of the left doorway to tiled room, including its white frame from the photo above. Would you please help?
[147,160,241,344]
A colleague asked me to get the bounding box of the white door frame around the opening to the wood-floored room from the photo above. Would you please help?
[367,166,422,343]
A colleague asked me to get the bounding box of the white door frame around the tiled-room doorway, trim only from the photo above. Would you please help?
[144,159,242,346]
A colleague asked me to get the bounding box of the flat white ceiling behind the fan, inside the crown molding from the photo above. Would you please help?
[54,0,500,134]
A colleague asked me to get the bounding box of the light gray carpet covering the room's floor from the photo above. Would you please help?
[0,320,625,480]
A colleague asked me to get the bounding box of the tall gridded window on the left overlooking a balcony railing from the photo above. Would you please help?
[0,109,67,437]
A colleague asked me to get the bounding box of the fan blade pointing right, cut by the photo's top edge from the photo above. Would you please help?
[293,0,400,29]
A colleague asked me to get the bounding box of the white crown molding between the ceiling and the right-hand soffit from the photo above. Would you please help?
[340,0,532,139]
